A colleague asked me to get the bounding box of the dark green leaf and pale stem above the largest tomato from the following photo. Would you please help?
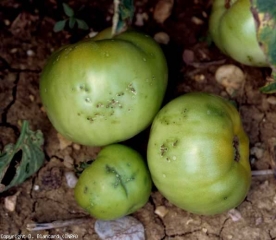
[112,0,134,35]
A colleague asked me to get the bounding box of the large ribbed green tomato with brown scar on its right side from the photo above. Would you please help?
[147,93,251,215]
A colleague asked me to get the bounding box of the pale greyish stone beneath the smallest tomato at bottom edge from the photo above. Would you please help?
[95,216,145,240]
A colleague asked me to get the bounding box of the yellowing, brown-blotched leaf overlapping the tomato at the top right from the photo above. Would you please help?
[251,0,276,93]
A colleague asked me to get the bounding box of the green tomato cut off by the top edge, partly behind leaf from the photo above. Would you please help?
[209,0,268,67]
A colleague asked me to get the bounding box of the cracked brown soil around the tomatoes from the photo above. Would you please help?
[0,0,276,240]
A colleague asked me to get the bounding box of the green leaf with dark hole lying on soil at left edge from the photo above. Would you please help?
[0,121,44,192]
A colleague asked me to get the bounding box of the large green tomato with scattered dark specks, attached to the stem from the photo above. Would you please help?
[40,29,168,146]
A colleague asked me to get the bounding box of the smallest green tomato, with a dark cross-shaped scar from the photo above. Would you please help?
[74,144,152,220]
